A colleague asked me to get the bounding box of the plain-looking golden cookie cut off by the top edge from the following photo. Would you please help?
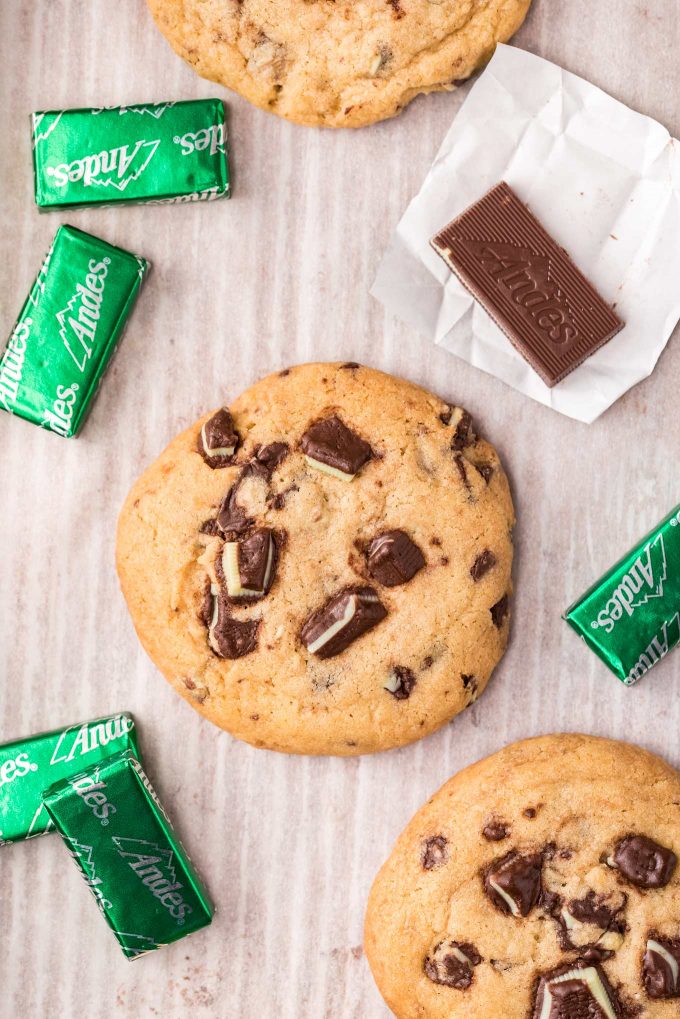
[148,0,531,127]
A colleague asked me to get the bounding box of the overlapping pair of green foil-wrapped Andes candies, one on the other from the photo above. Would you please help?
[0,713,213,959]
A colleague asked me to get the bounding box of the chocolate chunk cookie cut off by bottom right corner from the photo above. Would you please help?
[366,736,680,1019]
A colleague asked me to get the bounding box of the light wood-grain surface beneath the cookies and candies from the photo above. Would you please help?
[0,0,680,1019]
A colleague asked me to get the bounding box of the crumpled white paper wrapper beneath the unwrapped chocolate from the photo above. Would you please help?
[371,46,680,423]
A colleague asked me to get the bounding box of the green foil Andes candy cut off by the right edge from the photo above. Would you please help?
[565,506,680,686]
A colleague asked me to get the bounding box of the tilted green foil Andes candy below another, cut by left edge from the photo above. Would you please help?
[0,226,148,437]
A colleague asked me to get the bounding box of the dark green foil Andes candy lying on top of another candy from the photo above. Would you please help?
[43,751,213,959]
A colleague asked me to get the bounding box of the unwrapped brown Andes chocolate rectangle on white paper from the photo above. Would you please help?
[431,181,623,386]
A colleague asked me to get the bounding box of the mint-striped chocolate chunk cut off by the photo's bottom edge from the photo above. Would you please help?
[533,959,622,1019]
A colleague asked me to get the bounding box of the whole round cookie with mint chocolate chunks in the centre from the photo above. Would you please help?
[117,365,513,754]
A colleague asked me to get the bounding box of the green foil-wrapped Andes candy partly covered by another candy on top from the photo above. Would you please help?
[0,714,139,846]
